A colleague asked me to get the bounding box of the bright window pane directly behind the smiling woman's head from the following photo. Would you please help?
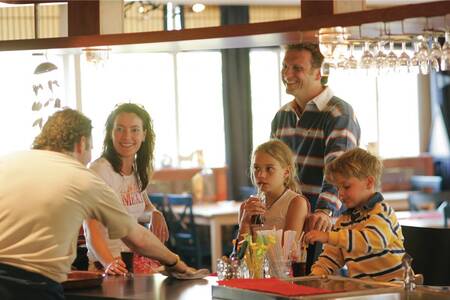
[81,53,177,166]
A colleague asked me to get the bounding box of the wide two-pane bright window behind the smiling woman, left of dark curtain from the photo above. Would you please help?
[81,52,225,168]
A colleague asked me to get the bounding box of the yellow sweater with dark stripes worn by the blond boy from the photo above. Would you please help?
[311,193,405,281]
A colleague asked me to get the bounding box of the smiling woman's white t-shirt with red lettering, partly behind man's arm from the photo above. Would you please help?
[84,158,149,262]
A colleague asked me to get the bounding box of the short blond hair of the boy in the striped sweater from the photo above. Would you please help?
[325,148,383,186]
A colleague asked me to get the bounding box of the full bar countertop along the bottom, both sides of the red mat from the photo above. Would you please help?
[65,274,450,300]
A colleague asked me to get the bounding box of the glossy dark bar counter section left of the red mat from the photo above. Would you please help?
[65,274,217,300]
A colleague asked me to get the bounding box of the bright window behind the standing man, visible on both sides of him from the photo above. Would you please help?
[250,49,420,158]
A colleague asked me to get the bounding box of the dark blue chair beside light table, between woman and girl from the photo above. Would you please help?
[166,194,211,268]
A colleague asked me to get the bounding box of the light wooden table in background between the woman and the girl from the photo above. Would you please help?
[173,200,241,272]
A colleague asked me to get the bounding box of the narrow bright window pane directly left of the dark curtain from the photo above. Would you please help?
[177,51,225,167]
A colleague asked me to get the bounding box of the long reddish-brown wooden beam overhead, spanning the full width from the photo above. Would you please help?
[0,0,450,52]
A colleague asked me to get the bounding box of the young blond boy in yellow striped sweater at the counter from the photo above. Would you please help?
[305,148,405,281]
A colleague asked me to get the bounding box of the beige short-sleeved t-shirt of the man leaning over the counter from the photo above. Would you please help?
[0,150,135,282]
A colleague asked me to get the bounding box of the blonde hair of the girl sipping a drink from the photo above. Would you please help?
[250,139,300,193]
